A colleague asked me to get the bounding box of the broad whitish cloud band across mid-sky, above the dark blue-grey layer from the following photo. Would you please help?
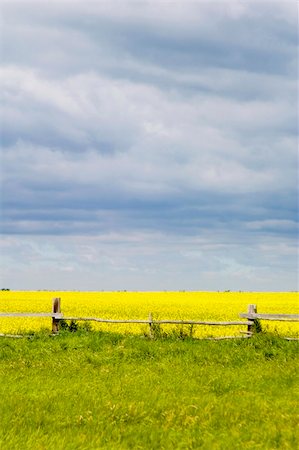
[0,67,296,197]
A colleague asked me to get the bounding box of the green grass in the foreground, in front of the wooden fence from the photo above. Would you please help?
[0,331,298,450]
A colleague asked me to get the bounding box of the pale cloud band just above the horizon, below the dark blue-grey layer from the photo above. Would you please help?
[1,233,297,291]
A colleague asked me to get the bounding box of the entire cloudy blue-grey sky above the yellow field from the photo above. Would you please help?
[0,0,298,291]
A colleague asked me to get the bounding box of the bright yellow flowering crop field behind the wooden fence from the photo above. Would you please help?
[0,291,299,337]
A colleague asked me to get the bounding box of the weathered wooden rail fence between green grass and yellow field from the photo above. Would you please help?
[0,298,299,340]
